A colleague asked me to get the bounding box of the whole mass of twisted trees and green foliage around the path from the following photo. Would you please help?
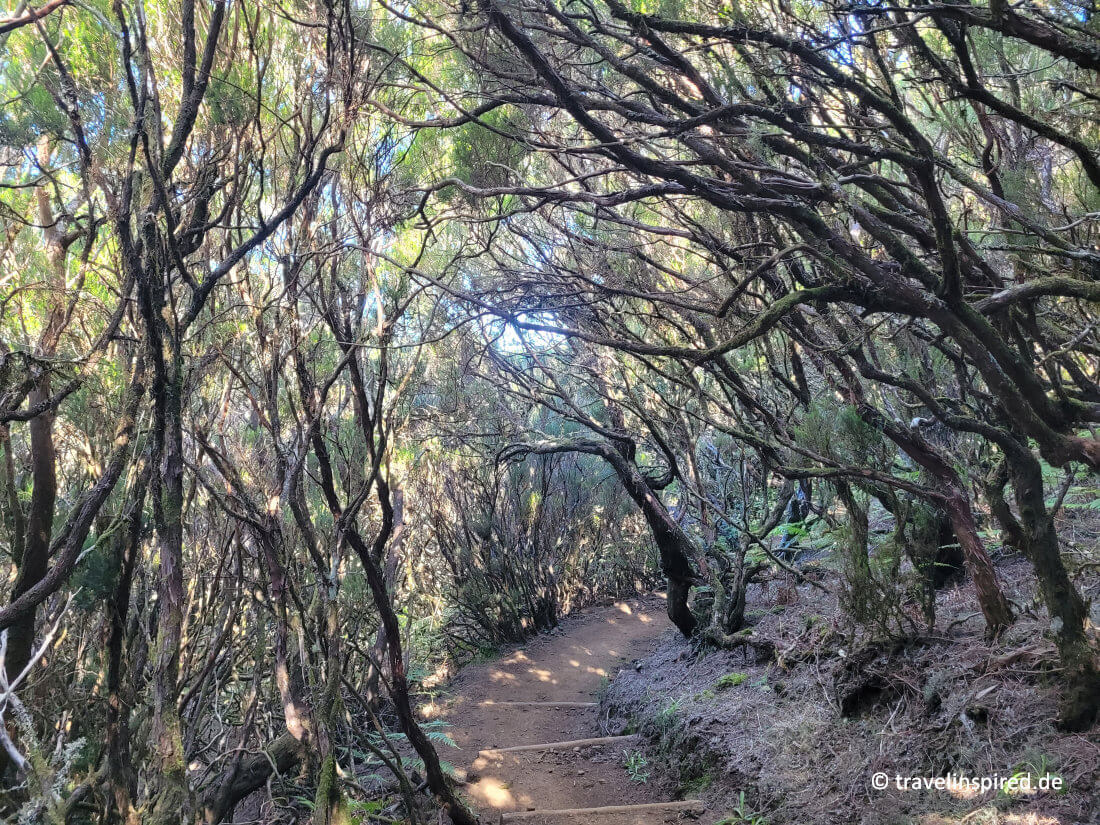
[0,0,1100,825]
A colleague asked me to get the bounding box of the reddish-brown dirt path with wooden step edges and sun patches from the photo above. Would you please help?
[431,601,699,825]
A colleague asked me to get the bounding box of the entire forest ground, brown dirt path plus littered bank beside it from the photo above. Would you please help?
[422,545,1100,825]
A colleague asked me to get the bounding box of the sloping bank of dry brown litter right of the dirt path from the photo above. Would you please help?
[601,558,1100,825]
